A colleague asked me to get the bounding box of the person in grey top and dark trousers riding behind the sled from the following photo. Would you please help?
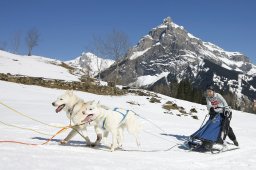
[206,85,239,146]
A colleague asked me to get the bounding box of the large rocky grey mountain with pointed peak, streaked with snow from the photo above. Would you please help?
[102,17,256,113]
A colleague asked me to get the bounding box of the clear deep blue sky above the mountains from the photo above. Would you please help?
[0,0,256,63]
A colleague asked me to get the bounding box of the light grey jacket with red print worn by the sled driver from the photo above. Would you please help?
[206,93,228,113]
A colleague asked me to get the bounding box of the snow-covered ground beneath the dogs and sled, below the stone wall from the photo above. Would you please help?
[0,81,256,170]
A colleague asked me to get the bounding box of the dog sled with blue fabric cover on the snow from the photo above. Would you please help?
[186,107,238,154]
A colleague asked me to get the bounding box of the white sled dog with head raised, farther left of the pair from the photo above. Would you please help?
[52,91,102,146]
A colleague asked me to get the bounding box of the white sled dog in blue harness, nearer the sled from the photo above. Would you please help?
[84,102,141,151]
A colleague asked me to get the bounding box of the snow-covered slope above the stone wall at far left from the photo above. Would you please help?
[0,50,79,81]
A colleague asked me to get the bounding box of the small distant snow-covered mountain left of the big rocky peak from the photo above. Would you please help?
[65,52,114,77]
